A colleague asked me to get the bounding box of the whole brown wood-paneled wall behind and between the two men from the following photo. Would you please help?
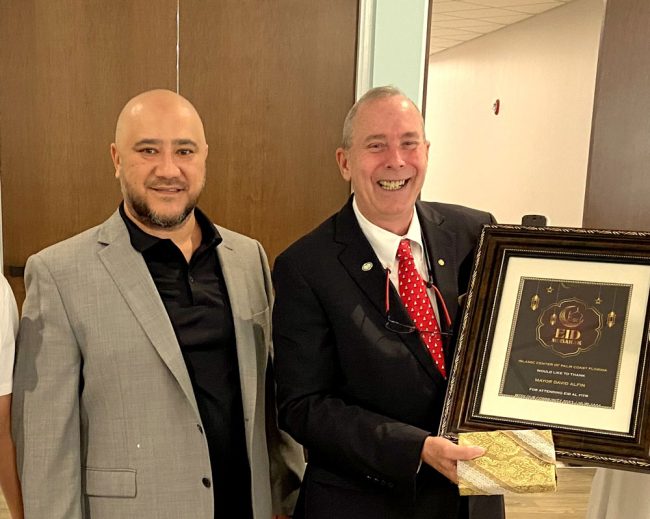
[0,0,358,301]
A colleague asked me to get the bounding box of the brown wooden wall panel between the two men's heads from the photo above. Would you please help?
[180,0,358,260]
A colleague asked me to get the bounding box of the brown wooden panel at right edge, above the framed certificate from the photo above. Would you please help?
[580,0,650,231]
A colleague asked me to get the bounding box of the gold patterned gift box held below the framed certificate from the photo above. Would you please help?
[458,430,557,496]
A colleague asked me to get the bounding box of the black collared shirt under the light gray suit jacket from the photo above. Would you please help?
[120,204,252,519]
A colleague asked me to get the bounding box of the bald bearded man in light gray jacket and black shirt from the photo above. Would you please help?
[13,90,304,519]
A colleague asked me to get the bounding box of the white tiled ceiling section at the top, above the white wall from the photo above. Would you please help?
[429,0,571,54]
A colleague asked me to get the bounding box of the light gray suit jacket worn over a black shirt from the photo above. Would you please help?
[13,212,304,519]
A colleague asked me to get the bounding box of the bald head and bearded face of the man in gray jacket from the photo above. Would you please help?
[111,90,208,237]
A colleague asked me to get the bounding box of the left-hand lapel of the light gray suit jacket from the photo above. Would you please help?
[98,212,199,416]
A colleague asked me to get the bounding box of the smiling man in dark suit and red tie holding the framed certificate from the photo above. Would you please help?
[273,87,503,519]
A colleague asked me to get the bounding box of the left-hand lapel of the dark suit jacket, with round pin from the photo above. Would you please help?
[335,198,444,384]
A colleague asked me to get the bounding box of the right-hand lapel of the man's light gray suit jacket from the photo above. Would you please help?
[217,236,254,452]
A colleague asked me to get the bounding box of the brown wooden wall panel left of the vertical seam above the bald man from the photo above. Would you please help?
[0,0,176,300]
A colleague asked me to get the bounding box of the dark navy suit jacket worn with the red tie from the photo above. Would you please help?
[273,198,502,519]
